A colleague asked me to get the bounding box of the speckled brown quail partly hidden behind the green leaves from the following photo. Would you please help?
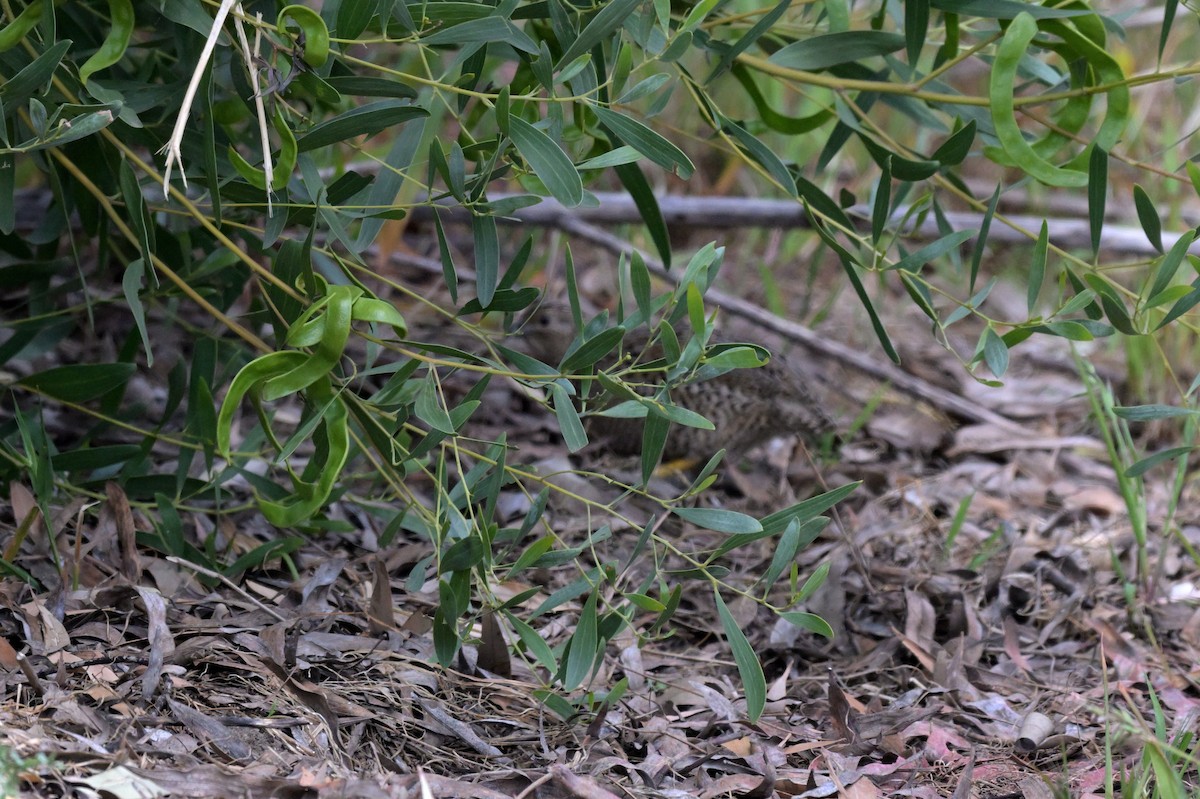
[523,305,834,464]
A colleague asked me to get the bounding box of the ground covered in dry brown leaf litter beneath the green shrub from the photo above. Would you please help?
[0,221,1200,799]
